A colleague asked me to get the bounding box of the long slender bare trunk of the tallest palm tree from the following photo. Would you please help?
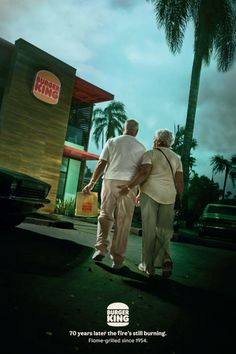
[181,50,202,191]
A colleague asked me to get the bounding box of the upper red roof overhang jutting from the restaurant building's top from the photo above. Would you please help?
[72,77,114,103]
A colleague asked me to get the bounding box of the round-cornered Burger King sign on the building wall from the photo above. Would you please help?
[33,70,61,104]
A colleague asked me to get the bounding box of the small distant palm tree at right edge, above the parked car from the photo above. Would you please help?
[211,155,236,199]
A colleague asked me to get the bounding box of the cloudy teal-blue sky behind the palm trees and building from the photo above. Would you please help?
[0,0,236,193]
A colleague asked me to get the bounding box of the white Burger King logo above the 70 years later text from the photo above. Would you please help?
[107,302,129,327]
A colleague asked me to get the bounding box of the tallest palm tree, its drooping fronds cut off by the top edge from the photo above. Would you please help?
[146,0,236,189]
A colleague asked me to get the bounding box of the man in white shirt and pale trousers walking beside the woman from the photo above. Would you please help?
[83,119,146,269]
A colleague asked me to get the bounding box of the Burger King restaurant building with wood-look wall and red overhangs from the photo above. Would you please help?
[0,39,114,212]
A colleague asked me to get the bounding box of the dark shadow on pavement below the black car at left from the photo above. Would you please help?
[0,229,91,276]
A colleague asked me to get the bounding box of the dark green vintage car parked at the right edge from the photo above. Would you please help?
[199,204,236,237]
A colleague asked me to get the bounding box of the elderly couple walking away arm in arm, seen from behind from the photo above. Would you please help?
[83,119,183,278]
